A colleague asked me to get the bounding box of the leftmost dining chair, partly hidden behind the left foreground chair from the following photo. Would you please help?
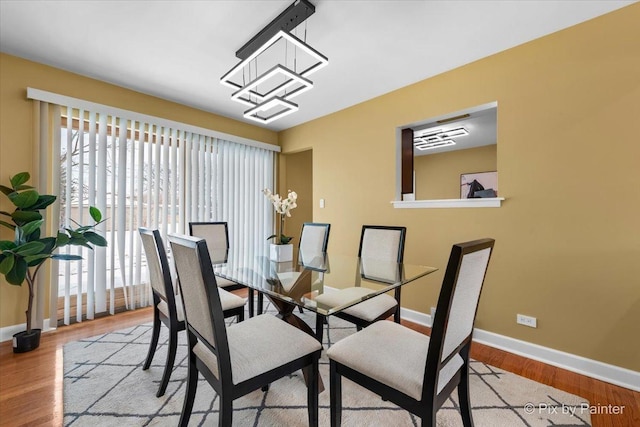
[138,227,245,397]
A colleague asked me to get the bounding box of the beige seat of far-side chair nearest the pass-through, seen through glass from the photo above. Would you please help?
[316,287,398,322]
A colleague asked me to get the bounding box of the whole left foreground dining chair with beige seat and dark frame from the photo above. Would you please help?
[169,235,322,426]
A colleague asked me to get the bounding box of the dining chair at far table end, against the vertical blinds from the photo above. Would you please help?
[189,221,255,317]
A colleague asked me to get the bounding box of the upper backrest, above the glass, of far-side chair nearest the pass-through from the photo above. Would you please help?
[358,225,407,262]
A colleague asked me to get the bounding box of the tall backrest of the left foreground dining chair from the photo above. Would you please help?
[169,234,231,381]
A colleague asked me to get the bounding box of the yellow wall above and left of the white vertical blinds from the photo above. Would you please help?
[0,54,278,327]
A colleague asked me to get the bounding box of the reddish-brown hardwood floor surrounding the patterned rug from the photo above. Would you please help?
[0,308,640,427]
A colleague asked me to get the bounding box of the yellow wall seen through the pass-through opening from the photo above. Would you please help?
[413,144,500,200]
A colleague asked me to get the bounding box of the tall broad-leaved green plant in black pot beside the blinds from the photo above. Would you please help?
[0,172,107,353]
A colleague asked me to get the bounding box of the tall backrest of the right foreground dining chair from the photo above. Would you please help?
[423,239,495,402]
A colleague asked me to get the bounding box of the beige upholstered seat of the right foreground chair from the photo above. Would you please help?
[328,321,463,400]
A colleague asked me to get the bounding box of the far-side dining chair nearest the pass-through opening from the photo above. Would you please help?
[327,225,407,330]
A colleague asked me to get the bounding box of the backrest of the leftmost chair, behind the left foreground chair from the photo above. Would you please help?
[138,227,175,307]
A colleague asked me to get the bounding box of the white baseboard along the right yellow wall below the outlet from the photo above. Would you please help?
[400,308,640,391]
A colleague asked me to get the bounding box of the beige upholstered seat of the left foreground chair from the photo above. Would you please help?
[193,314,322,384]
